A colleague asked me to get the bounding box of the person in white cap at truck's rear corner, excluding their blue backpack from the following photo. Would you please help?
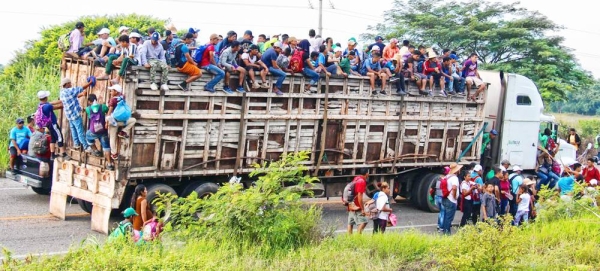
[105,84,137,160]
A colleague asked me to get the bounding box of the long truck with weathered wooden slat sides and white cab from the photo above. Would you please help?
[50,58,574,233]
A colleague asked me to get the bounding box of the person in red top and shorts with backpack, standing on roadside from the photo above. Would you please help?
[348,168,369,234]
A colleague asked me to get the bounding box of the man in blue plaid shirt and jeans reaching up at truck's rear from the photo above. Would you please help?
[60,76,96,153]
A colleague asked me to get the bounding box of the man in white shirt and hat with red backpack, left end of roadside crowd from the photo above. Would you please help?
[440,163,463,234]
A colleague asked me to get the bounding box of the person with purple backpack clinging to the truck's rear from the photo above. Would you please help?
[85,94,115,170]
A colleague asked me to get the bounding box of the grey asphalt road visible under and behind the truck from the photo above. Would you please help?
[0,179,440,259]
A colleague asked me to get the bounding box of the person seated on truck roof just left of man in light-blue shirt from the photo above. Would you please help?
[97,35,140,84]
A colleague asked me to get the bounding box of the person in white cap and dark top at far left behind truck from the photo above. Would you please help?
[34,90,71,160]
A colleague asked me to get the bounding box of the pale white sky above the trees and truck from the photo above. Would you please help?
[0,0,600,78]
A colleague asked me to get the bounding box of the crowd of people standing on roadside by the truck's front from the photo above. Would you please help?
[342,128,600,234]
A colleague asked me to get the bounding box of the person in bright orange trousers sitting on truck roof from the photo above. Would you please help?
[175,33,202,91]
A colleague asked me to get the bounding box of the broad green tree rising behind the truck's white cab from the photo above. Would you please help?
[363,0,593,102]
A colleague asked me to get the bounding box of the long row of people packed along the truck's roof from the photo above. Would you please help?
[66,22,486,101]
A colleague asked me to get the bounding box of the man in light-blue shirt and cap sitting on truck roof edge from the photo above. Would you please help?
[140,32,169,91]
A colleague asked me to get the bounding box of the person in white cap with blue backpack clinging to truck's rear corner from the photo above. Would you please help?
[105,84,137,160]
